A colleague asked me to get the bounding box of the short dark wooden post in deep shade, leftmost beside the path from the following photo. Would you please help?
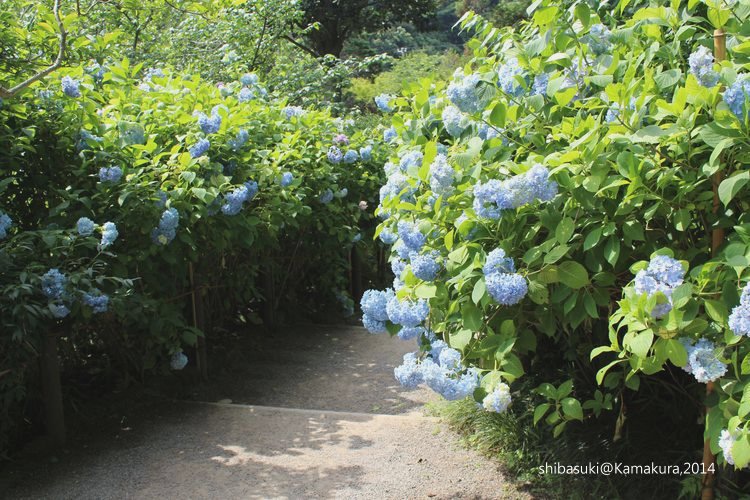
[39,332,65,447]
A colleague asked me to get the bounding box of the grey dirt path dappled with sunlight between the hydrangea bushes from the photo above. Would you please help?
[6,327,527,500]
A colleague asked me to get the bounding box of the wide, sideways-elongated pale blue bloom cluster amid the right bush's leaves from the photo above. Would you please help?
[473,164,557,219]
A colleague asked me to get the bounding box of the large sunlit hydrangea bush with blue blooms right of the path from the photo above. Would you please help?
[362,0,750,480]
